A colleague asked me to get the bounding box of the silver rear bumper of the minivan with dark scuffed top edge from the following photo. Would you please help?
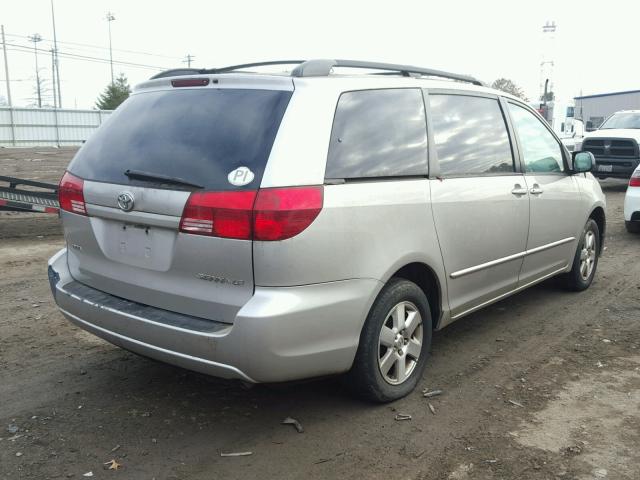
[49,250,382,382]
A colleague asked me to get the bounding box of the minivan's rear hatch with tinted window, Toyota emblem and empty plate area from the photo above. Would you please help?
[63,77,292,322]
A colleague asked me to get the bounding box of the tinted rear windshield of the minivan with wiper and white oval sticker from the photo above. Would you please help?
[69,88,291,190]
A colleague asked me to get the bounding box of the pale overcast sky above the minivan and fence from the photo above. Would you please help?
[0,0,640,108]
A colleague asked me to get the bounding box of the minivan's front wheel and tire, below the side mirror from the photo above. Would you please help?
[565,218,600,292]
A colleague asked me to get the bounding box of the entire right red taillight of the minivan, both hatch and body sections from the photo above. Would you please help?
[180,186,323,241]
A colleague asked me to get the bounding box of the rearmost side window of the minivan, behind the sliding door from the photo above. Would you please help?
[325,89,427,178]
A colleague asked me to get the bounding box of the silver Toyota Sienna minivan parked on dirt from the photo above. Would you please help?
[49,60,605,402]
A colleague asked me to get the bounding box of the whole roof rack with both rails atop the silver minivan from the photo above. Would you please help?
[151,59,484,86]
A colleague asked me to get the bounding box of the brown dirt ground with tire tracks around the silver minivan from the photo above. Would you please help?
[0,150,640,480]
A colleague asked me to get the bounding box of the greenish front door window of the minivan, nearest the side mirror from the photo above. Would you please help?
[509,103,564,172]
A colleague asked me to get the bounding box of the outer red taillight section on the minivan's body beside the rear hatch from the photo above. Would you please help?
[253,186,323,240]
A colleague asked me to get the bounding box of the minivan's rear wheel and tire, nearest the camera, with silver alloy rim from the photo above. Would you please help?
[345,278,432,403]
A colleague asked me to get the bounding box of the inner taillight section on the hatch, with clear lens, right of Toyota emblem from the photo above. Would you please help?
[180,191,256,240]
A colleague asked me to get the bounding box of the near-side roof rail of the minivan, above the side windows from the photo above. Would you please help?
[291,60,484,86]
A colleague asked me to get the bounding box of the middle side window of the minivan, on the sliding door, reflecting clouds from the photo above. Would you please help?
[429,94,514,175]
